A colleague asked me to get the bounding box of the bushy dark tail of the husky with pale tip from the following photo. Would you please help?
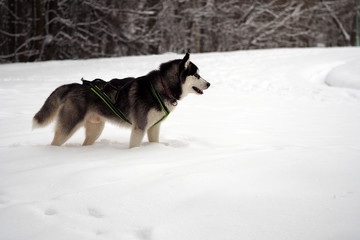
[32,85,70,129]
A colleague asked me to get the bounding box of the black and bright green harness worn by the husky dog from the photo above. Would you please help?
[81,78,170,127]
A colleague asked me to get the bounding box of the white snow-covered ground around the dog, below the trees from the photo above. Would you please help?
[0,48,360,240]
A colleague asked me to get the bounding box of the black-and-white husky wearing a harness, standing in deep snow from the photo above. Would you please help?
[33,53,210,148]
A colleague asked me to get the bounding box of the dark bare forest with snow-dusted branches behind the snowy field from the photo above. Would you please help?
[0,0,359,63]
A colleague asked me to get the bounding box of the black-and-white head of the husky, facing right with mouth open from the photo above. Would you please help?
[179,53,210,98]
